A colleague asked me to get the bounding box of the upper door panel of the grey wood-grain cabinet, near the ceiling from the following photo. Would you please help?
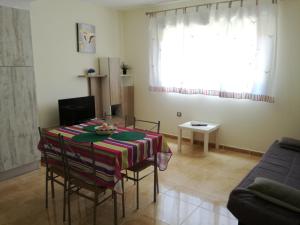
[0,6,33,66]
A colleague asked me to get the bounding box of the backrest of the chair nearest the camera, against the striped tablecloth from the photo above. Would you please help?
[61,136,96,185]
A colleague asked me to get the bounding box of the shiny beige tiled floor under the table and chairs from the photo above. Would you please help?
[0,139,259,225]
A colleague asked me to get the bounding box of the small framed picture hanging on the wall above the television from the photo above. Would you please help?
[76,23,96,53]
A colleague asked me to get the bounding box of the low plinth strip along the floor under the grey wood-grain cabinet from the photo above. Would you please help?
[0,160,40,181]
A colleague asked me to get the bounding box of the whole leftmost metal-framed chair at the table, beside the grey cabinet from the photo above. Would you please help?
[39,127,67,221]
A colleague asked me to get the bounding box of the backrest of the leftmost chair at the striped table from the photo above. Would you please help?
[39,127,65,170]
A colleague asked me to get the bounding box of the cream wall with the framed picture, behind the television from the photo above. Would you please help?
[30,0,122,127]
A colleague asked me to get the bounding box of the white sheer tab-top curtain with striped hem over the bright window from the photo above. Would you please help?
[149,0,277,102]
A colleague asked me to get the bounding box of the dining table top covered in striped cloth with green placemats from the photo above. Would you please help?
[38,119,172,193]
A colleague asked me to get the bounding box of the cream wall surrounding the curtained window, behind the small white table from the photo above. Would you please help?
[123,0,300,152]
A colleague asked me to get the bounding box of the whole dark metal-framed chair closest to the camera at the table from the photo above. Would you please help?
[61,136,125,225]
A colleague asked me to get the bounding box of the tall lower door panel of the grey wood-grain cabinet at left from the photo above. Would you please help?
[0,67,40,172]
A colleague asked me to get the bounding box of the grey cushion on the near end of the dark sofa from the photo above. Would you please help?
[248,177,300,213]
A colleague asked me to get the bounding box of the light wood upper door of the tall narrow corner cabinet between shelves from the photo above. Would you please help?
[109,58,121,105]
